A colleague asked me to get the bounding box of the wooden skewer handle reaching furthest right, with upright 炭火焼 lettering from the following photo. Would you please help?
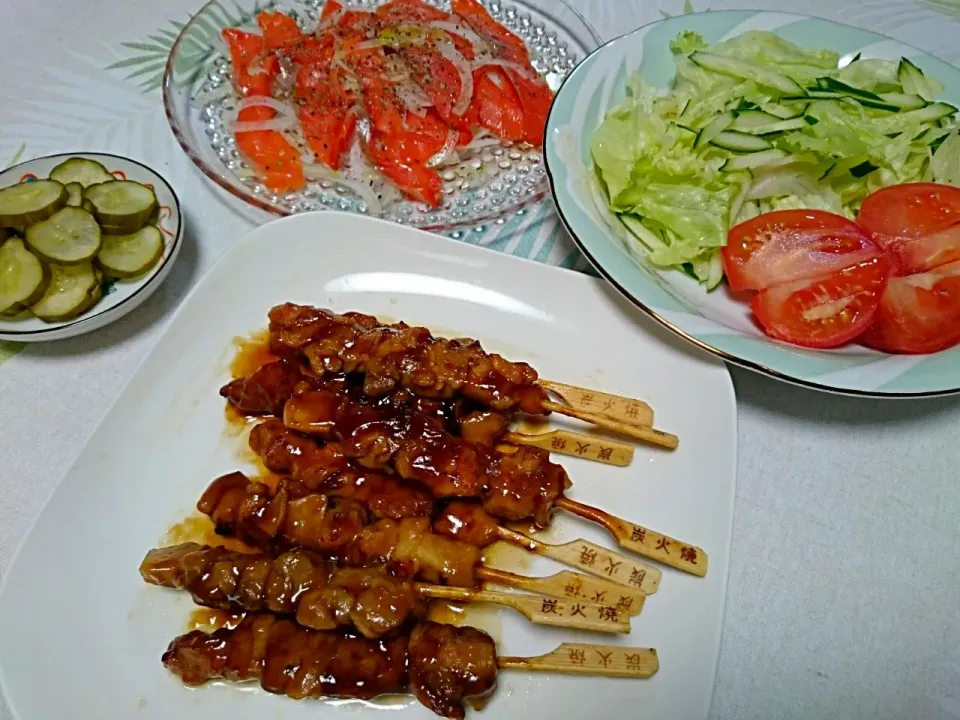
[555,497,708,577]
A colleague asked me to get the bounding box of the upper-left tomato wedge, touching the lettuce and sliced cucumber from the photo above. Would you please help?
[723,210,881,290]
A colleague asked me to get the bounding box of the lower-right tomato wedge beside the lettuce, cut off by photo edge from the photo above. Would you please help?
[860,262,960,353]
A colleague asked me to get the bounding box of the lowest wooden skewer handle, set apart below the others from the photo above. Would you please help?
[497,643,660,680]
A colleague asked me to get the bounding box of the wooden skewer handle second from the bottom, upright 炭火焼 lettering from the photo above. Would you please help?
[416,583,630,634]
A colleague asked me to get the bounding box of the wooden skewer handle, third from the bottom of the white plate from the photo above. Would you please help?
[477,567,647,615]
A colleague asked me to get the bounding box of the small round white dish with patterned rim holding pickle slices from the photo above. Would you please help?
[0,153,183,342]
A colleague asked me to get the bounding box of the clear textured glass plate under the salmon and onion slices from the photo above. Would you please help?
[163,0,600,230]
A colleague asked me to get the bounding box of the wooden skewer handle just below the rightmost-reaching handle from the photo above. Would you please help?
[497,527,660,595]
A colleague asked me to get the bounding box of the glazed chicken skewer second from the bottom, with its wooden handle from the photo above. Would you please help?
[140,543,630,638]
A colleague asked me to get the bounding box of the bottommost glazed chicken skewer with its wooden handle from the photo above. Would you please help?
[162,614,659,720]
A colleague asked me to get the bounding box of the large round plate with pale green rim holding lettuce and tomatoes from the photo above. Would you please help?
[545,10,960,397]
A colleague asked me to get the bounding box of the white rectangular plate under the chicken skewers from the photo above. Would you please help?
[0,212,737,720]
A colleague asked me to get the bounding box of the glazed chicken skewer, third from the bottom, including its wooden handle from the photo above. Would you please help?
[197,472,651,614]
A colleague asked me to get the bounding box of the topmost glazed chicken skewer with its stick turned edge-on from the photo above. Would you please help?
[269,303,677,448]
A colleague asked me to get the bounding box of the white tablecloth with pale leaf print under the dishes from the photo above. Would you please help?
[0,0,960,720]
